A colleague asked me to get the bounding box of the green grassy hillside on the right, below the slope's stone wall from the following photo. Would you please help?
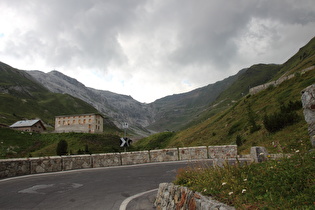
[168,71,315,153]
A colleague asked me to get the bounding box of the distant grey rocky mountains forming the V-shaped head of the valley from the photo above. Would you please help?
[28,69,252,136]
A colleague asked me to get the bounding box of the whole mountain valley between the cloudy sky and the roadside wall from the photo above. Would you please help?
[0,38,315,157]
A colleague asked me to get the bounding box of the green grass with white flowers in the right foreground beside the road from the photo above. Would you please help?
[174,150,315,209]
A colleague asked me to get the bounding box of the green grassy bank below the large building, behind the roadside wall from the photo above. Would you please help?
[0,128,124,159]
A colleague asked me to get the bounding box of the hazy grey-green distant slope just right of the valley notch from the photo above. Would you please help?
[149,71,243,131]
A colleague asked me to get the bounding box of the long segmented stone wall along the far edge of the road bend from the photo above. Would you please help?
[0,145,243,179]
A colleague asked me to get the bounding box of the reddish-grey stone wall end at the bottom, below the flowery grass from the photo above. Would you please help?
[154,183,235,210]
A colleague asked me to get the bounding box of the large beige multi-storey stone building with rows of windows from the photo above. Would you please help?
[55,114,103,133]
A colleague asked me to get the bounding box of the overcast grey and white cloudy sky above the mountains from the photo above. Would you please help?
[0,0,315,103]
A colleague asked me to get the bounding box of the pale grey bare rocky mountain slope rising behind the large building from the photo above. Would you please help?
[28,71,153,135]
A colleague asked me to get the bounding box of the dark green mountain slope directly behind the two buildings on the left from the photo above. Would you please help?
[0,62,103,126]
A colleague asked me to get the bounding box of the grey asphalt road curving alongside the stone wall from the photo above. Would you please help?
[0,162,210,210]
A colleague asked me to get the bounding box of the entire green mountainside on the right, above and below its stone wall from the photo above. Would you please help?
[137,38,315,153]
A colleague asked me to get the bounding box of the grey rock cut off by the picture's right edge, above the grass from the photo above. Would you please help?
[301,84,315,147]
